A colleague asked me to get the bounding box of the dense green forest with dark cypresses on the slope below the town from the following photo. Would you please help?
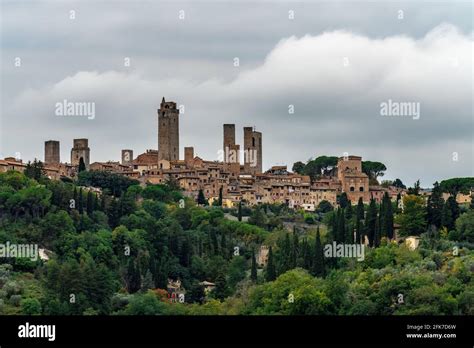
[0,163,474,315]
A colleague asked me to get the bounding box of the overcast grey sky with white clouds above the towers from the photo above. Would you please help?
[0,0,474,187]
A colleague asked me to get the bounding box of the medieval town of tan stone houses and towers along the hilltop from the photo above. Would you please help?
[0,97,412,211]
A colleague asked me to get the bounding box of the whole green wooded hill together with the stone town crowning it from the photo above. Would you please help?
[0,98,474,315]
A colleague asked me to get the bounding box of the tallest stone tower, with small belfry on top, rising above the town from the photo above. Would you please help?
[158,97,179,161]
